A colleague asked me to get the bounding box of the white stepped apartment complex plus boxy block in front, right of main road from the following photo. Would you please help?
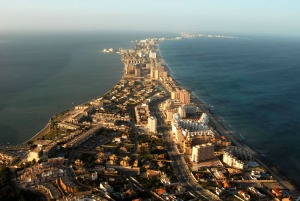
[165,107,231,162]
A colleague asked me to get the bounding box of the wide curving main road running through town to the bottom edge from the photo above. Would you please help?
[149,99,220,200]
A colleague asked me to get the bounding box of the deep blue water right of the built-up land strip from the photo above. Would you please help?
[160,37,300,186]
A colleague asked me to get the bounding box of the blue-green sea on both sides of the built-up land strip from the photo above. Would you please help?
[0,32,300,186]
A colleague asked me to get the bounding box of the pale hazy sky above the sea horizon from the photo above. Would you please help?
[0,0,300,36]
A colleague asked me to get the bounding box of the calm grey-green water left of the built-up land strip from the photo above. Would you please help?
[0,32,166,145]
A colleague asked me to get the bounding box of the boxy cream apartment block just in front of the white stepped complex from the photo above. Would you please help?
[191,143,214,163]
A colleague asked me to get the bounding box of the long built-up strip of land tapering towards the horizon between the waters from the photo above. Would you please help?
[0,33,299,201]
